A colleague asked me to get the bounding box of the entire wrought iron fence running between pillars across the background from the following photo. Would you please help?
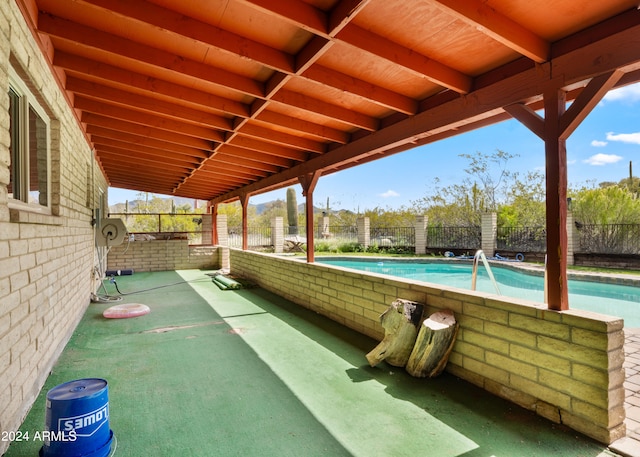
[110,213,640,254]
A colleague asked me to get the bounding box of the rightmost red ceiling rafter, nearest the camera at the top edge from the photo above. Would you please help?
[430,0,551,63]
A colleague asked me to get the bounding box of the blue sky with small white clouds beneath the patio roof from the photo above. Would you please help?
[109,83,640,212]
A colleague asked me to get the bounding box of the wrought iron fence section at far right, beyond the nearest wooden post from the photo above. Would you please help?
[576,223,640,254]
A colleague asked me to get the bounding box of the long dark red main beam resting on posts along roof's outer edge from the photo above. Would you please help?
[215,17,640,201]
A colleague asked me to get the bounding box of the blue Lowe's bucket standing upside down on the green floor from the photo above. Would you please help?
[40,378,113,457]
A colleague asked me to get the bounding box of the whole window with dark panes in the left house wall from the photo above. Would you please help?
[8,70,51,212]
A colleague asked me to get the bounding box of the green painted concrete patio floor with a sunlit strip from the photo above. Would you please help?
[6,270,616,457]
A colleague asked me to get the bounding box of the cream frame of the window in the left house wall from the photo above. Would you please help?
[7,67,52,215]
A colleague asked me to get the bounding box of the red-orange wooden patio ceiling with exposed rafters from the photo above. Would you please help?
[17,0,640,201]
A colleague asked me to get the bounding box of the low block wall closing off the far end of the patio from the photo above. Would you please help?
[107,240,220,272]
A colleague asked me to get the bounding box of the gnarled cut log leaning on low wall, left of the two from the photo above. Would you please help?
[366,298,423,367]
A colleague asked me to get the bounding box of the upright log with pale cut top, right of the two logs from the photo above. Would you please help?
[406,310,458,378]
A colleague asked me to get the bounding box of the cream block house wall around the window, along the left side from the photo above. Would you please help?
[0,1,107,454]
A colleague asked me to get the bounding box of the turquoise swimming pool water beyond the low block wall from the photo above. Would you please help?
[316,258,640,328]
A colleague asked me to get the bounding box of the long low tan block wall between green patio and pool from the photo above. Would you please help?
[231,249,625,444]
